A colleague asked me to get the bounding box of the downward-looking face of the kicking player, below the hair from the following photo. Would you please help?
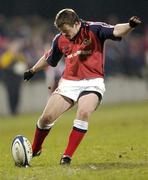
[60,22,81,39]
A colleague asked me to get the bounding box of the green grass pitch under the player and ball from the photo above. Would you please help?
[0,102,148,180]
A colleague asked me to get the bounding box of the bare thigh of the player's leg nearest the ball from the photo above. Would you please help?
[43,94,73,120]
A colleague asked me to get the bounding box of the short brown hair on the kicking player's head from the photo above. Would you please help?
[54,8,80,28]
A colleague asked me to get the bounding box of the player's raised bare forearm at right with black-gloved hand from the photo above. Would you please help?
[113,16,141,37]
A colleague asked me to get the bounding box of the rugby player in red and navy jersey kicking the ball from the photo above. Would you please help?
[24,9,141,165]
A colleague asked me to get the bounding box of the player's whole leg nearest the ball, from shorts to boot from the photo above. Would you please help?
[32,94,73,156]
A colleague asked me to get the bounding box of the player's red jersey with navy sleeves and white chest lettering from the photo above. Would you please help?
[45,21,121,80]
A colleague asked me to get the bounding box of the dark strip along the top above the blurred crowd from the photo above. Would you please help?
[0,0,148,23]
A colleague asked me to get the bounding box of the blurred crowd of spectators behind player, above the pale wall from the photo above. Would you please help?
[0,15,148,114]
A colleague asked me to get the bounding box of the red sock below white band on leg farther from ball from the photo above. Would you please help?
[64,127,87,157]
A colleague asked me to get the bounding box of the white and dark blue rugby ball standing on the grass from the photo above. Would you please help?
[11,135,32,167]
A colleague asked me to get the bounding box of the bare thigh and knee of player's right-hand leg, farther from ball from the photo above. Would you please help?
[77,93,100,119]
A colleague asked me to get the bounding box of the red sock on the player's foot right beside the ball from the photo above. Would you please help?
[32,127,51,154]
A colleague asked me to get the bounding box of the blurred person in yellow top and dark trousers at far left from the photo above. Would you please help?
[0,39,26,115]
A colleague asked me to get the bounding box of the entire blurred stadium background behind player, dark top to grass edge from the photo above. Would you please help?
[0,0,148,114]
